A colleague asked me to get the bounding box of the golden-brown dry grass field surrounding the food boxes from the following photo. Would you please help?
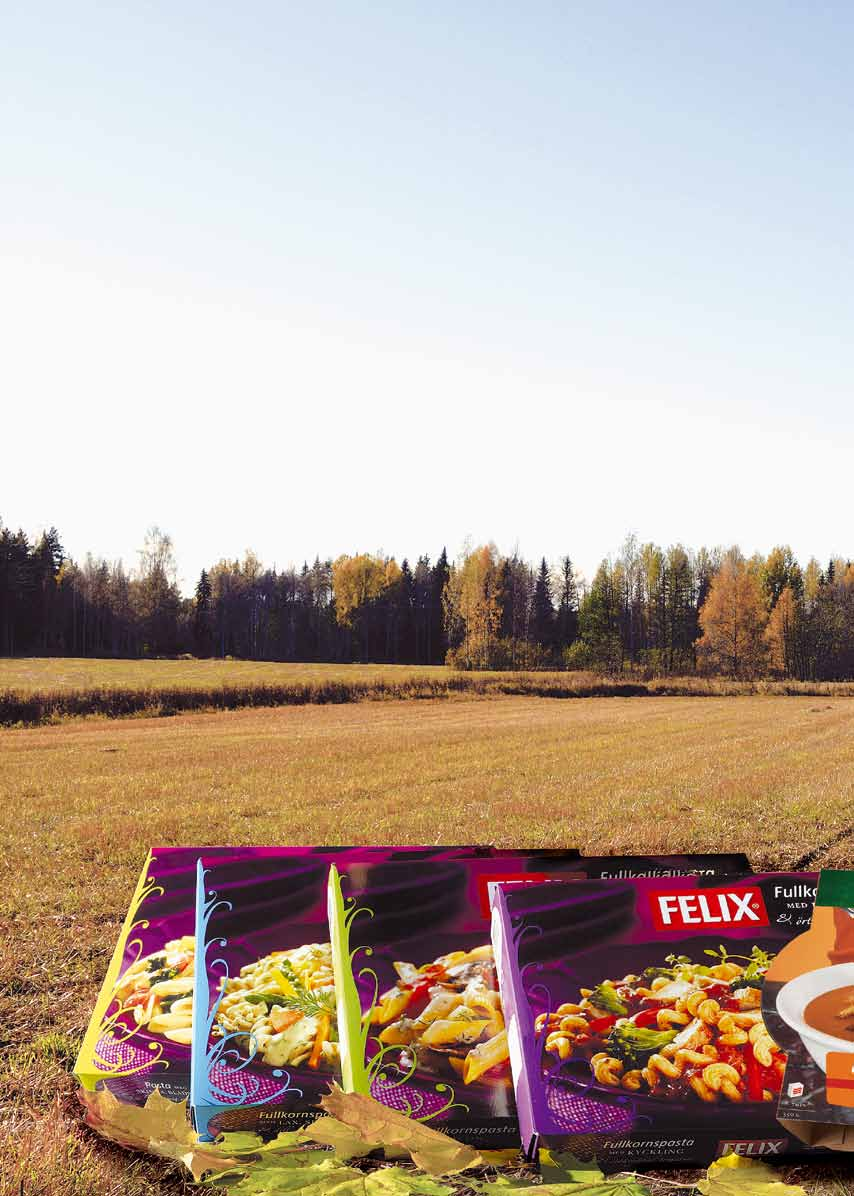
[0,661,854,1196]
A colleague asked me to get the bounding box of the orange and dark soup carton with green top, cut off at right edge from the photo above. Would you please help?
[762,871,854,1151]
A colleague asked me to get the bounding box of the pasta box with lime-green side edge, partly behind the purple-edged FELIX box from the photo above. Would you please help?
[329,852,744,1146]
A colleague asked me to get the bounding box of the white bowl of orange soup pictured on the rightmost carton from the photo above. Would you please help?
[777,963,854,1072]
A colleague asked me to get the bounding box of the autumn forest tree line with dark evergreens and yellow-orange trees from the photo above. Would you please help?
[0,524,854,681]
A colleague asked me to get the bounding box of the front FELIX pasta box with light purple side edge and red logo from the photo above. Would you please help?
[490,873,817,1170]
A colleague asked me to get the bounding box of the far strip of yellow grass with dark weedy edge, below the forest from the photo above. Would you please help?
[0,658,854,727]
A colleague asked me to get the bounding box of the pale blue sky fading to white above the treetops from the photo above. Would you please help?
[0,0,854,591]
